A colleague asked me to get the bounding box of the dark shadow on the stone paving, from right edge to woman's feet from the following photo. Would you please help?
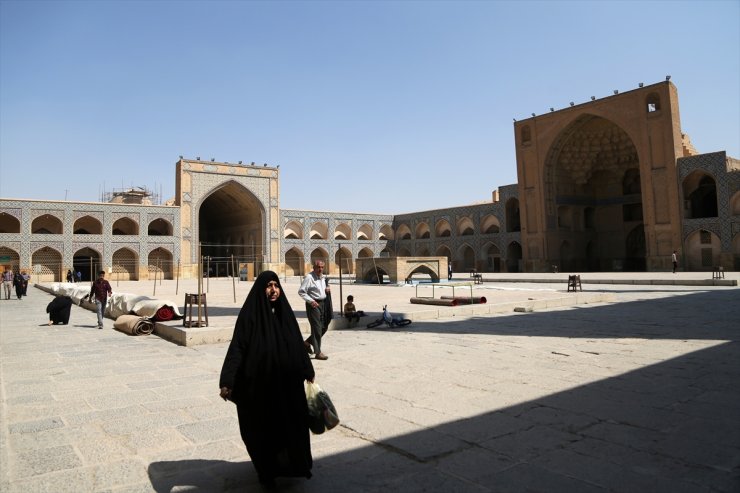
[149,290,740,493]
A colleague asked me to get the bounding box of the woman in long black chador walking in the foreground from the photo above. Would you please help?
[219,271,314,486]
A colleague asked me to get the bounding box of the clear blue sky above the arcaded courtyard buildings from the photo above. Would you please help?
[0,0,740,213]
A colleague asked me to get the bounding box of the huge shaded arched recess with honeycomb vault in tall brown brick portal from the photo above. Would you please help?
[544,114,647,271]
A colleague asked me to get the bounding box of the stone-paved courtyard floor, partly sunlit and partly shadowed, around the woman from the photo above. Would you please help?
[0,274,740,493]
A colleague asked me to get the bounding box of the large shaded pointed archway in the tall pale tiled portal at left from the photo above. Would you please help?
[198,181,266,264]
